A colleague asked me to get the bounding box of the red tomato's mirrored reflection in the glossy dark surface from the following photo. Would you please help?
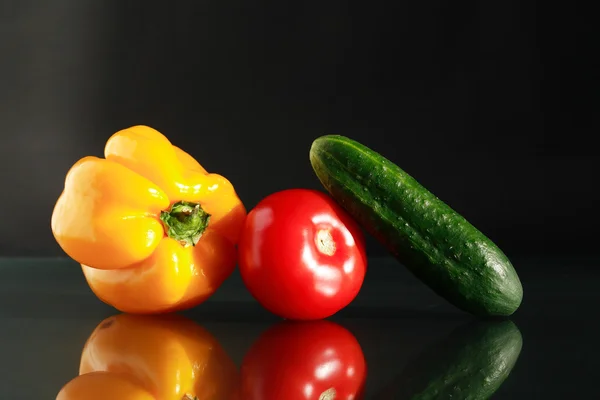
[241,320,366,400]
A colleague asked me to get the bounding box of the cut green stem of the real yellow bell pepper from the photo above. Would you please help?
[160,201,210,247]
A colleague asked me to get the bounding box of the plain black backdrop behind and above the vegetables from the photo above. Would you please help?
[0,0,599,256]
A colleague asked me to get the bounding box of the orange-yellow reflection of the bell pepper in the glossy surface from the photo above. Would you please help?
[57,314,238,400]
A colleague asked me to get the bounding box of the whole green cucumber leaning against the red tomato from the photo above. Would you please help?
[310,135,523,316]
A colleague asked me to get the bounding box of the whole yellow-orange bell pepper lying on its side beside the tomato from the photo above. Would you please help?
[52,126,246,313]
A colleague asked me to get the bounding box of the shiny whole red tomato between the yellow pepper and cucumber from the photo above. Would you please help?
[238,189,366,320]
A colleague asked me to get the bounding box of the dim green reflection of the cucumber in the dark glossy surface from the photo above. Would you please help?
[375,321,523,400]
